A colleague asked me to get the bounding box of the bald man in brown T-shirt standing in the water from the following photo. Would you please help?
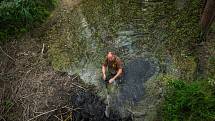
[102,52,123,83]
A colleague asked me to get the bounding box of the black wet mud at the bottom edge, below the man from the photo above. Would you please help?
[71,91,132,121]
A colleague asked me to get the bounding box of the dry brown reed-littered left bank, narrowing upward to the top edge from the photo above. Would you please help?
[0,0,87,121]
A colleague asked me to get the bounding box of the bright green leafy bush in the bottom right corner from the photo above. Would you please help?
[162,80,215,121]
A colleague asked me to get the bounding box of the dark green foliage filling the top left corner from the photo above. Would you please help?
[0,0,57,44]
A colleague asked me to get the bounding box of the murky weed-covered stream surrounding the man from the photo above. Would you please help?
[46,0,181,121]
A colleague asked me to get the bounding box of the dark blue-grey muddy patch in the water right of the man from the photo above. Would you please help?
[119,58,156,103]
